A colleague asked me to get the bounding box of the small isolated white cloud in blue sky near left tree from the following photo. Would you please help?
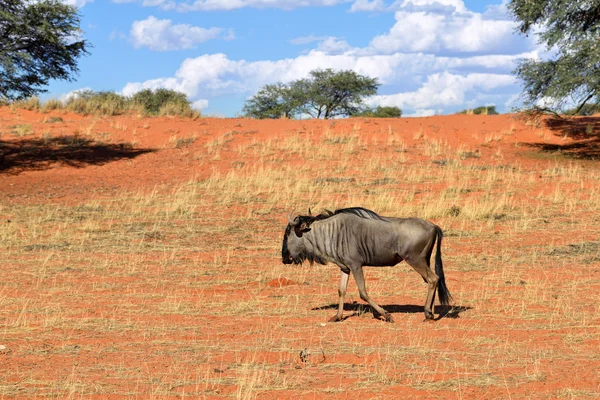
[129,16,225,51]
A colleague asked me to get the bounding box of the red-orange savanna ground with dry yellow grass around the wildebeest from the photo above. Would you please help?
[0,107,600,399]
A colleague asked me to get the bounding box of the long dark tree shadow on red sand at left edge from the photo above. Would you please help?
[0,135,156,174]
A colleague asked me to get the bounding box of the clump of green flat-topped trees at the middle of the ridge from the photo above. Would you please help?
[243,69,379,119]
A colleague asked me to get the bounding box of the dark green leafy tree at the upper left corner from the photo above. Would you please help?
[0,0,89,101]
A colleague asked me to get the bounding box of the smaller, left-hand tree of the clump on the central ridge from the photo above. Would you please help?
[242,82,305,119]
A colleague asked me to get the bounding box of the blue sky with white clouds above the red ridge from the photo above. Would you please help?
[49,0,542,117]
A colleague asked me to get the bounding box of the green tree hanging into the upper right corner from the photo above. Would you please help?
[508,0,600,114]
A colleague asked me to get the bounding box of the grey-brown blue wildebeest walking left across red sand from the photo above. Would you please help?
[281,207,452,322]
